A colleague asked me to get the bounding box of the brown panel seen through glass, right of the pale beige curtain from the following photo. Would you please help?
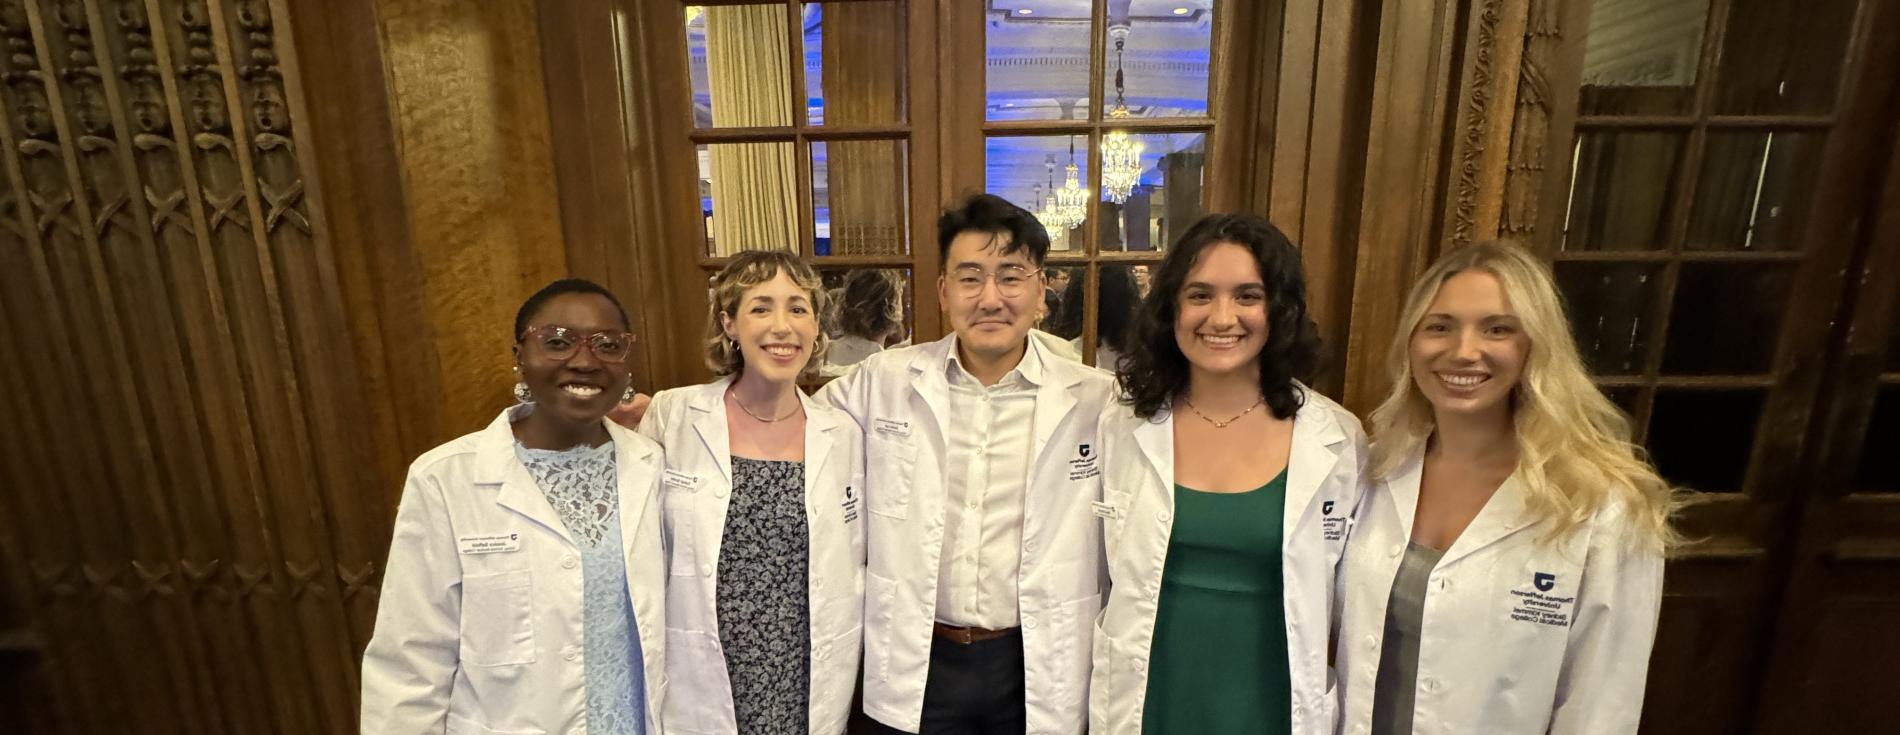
[823,2,908,254]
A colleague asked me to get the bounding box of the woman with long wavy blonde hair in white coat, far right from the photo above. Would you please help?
[1338,243,1674,733]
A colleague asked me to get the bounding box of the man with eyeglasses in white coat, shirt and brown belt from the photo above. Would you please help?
[819,194,1113,733]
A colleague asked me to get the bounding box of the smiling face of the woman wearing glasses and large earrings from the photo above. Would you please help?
[515,292,633,427]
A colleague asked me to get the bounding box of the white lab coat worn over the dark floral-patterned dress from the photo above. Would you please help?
[640,378,865,735]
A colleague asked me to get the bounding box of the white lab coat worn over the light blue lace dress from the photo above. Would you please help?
[363,406,667,735]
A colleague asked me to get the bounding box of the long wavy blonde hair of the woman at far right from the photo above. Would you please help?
[1370,241,1682,551]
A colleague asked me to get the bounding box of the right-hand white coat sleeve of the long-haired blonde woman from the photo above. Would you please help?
[1550,524,1663,735]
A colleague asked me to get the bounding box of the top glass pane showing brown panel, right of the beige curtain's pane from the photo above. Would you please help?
[806,0,908,125]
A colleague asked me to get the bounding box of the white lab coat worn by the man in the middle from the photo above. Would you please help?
[819,334,1113,733]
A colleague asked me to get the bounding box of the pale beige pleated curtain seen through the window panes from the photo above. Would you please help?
[705,6,798,254]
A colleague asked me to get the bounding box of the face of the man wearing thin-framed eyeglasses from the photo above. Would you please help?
[937,232,1043,359]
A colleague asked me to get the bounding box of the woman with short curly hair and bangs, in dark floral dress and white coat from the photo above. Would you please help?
[640,251,865,735]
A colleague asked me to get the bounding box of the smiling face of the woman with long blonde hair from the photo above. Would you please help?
[1408,270,1531,416]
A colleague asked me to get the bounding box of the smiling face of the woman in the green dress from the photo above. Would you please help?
[1174,243,1267,374]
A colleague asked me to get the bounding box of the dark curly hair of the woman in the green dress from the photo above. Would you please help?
[1115,215,1321,420]
